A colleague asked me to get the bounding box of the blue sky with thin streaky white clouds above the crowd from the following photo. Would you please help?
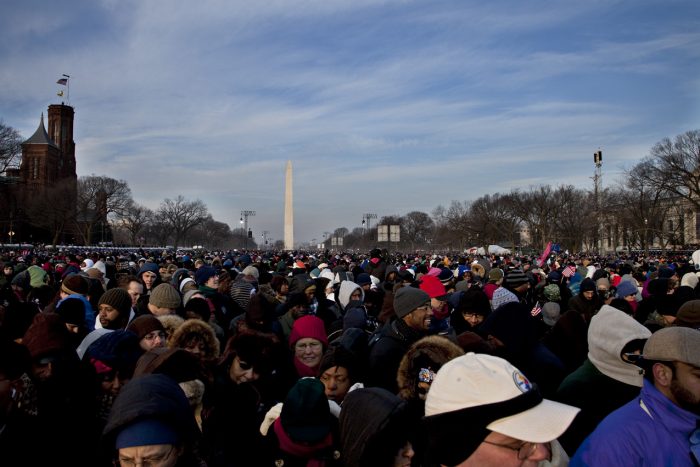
[0,0,700,247]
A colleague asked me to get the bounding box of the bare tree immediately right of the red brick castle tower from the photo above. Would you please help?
[77,174,133,245]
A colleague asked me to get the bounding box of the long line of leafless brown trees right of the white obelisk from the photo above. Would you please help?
[325,130,700,251]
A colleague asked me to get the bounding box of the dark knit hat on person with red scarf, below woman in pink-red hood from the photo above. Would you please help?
[280,378,331,443]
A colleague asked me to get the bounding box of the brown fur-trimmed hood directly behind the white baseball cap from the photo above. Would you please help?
[396,336,464,400]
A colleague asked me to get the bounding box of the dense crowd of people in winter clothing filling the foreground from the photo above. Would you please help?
[0,248,700,467]
